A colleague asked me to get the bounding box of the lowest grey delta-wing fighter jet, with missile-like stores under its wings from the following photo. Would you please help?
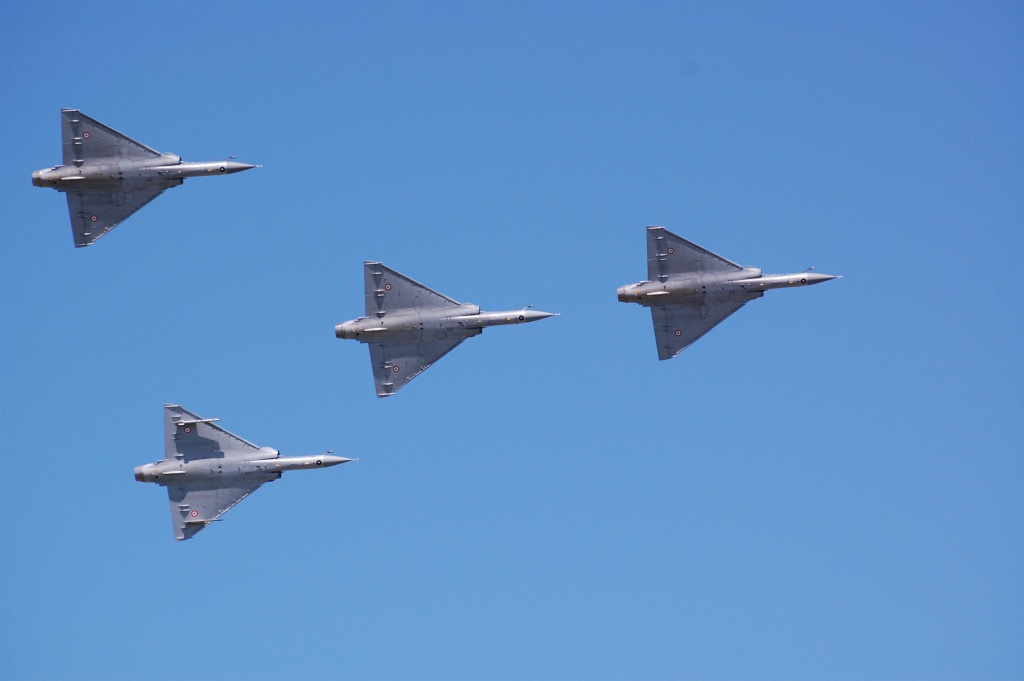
[135,405,352,542]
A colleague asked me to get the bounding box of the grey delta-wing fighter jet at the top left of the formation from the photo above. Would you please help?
[32,109,258,248]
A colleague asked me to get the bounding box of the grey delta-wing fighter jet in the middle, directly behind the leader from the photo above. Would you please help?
[334,262,554,397]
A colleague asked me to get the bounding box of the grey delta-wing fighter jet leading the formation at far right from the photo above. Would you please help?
[618,227,837,359]
